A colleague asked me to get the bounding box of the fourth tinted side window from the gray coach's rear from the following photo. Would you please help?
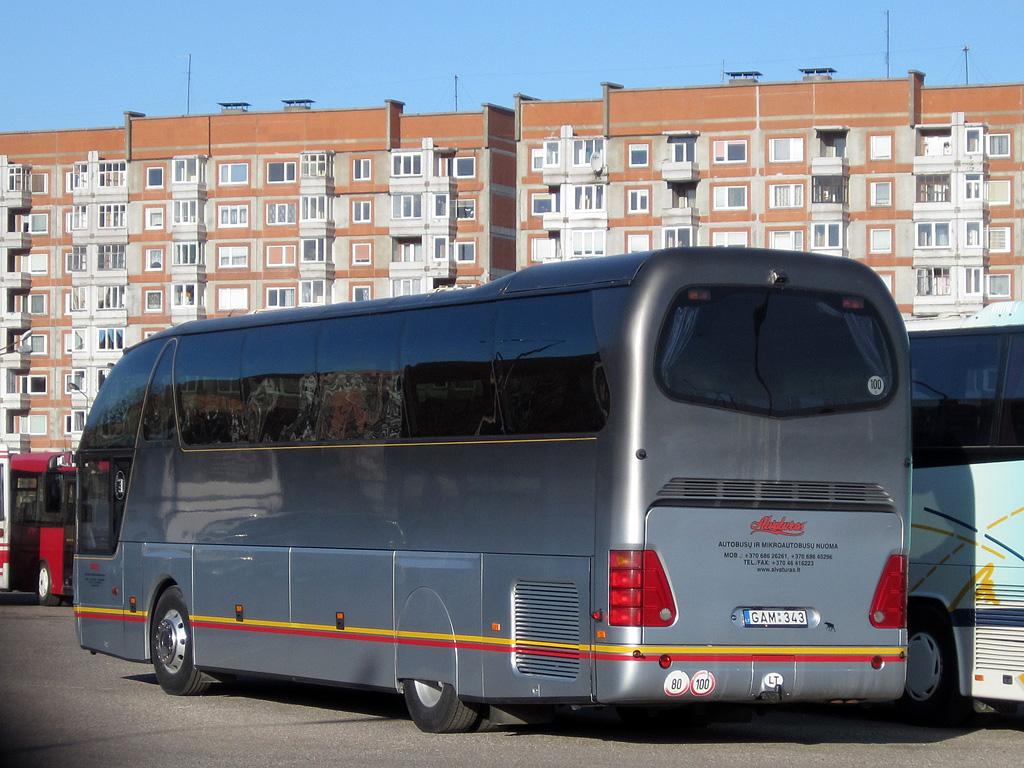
[242,323,319,442]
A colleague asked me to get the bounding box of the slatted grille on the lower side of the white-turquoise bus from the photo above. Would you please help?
[975,585,1024,673]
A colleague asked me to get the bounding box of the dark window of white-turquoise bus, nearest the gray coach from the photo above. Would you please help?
[910,334,999,447]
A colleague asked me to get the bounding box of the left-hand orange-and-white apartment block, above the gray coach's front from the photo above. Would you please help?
[0,101,515,453]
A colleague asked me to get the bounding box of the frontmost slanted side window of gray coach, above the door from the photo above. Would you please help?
[79,343,161,451]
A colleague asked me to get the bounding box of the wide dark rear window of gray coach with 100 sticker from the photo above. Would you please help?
[654,286,896,417]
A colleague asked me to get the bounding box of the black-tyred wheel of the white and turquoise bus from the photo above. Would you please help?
[896,608,974,728]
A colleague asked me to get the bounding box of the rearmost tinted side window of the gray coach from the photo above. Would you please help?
[495,293,608,434]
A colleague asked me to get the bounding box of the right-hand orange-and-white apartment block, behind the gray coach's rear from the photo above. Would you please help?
[515,69,1024,316]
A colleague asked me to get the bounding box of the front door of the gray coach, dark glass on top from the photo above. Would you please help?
[75,455,132,655]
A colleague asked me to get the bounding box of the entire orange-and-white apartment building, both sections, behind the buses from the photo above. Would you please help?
[0,68,1024,453]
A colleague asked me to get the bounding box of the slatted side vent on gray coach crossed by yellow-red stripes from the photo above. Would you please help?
[512,582,580,680]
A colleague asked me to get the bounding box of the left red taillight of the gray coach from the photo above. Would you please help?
[608,549,676,627]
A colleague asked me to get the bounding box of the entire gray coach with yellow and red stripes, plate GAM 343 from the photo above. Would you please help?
[75,248,910,732]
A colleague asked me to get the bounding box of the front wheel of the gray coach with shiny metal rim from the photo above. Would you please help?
[150,587,210,696]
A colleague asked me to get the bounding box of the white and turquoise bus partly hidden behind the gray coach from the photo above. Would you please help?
[899,302,1024,725]
